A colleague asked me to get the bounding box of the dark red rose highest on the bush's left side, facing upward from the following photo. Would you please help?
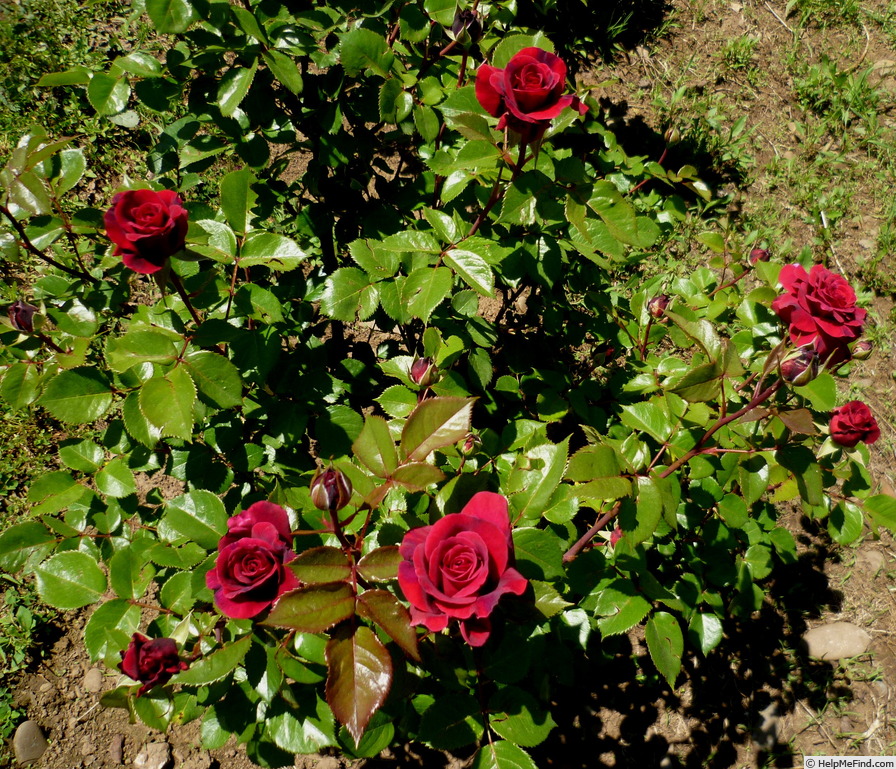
[104,190,187,275]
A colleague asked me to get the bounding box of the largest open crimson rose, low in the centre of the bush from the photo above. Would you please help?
[398,491,529,646]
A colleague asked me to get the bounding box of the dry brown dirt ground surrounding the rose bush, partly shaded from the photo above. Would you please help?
[8,0,896,769]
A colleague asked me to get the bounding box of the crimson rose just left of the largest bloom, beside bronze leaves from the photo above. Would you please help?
[205,502,301,619]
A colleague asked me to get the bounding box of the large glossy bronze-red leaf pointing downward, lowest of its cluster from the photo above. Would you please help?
[326,626,392,745]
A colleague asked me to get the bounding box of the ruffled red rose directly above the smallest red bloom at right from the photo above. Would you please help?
[772,264,867,364]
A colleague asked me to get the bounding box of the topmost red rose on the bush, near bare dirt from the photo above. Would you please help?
[476,48,588,142]
